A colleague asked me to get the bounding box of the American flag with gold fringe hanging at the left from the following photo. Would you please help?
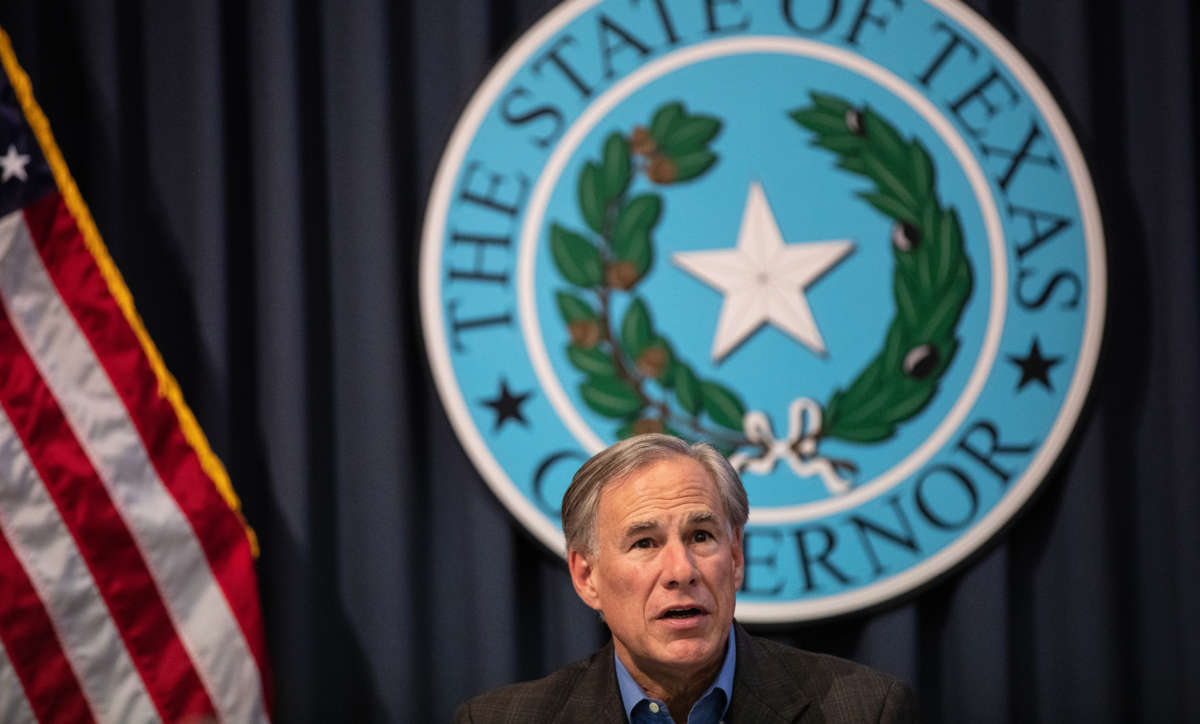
[0,30,269,722]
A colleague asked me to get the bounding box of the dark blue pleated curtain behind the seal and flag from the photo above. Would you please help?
[0,0,1200,722]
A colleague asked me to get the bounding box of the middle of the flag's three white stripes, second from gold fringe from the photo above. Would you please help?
[0,409,158,722]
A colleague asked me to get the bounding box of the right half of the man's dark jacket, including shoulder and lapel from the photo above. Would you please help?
[726,626,914,723]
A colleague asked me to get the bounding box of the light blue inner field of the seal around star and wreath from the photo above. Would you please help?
[536,54,991,507]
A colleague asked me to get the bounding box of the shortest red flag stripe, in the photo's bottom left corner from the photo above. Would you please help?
[0,523,94,722]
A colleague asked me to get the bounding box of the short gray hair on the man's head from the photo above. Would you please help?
[563,433,750,554]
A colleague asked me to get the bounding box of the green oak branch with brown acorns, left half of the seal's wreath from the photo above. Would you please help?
[550,102,746,451]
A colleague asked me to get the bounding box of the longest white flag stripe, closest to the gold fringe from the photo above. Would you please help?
[0,213,266,722]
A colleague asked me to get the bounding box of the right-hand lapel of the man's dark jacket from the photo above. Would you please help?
[725,622,812,724]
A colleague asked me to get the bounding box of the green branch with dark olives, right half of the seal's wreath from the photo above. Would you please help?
[790,92,972,442]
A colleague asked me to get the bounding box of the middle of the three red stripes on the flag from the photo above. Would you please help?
[0,302,215,722]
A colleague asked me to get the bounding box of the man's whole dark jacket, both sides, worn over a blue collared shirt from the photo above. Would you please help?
[455,624,914,724]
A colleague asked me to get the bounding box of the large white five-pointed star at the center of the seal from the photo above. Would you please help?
[672,181,854,360]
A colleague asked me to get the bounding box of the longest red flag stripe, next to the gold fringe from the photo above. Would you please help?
[25,193,271,711]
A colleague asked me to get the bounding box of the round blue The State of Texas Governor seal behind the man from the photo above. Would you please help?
[420,0,1105,622]
